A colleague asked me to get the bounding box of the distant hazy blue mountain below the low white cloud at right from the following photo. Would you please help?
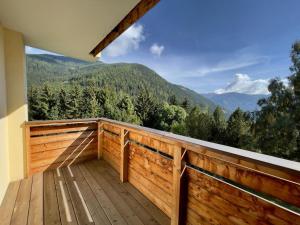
[202,92,267,112]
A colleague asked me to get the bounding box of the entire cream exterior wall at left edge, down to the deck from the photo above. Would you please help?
[0,23,28,203]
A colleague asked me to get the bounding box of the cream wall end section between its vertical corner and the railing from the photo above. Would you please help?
[4,29,28,181]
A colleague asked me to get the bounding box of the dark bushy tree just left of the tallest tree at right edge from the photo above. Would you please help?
[254,79,299,159]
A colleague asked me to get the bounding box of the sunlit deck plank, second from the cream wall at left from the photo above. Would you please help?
[10,177,32,225]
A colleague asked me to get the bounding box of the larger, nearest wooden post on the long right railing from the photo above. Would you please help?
[171,146,186,225]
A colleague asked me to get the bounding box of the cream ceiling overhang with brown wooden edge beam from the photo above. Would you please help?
[0,0,159,60]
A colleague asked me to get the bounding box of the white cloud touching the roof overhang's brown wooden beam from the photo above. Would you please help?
[104,24,145,57]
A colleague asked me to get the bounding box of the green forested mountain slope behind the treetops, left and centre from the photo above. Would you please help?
[27,54,216,110]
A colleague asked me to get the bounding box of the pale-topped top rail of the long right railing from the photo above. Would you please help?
[100,118,300,172]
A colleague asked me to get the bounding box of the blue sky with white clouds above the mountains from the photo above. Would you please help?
[27,0,300,94]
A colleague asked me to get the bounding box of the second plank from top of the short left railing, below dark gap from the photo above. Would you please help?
[30,130,98,146]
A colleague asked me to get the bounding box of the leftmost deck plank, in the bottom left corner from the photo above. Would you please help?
[0,181,21,225]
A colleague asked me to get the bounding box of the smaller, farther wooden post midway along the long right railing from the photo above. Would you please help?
[120,128,129,183]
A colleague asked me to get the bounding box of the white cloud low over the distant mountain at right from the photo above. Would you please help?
[215,74,269,95]
